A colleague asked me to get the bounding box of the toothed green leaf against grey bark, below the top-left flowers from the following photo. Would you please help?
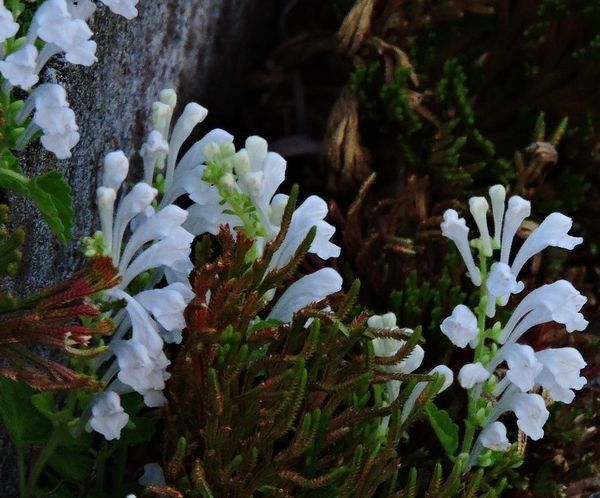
[29,171,73,244]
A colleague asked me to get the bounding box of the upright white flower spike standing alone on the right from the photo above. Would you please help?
[440,185,588,465]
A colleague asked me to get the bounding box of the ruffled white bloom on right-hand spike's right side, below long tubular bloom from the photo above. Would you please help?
[536,348,587,403]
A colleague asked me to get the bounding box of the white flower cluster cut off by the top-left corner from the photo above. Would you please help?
[0,0,139,159]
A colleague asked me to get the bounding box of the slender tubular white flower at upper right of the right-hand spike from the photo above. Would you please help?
[511,213,583,275]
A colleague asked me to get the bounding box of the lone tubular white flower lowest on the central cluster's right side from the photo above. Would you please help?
[269,268,342,322]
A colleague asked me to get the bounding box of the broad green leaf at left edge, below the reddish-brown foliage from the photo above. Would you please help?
[0,378,52,448]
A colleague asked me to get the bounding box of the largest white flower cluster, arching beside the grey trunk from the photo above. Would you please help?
[87,90,342,439]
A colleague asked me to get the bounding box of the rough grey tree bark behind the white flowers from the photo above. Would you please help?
[0,0,275,490]
